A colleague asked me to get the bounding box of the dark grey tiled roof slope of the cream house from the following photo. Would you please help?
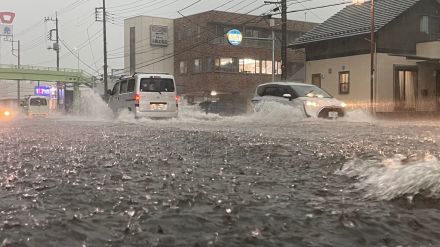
[291,0,422,46]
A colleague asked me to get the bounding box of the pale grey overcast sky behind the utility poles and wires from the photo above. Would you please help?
[0,0,350,74]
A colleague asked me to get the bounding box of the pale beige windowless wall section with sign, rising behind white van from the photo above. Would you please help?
[124,16,174,74]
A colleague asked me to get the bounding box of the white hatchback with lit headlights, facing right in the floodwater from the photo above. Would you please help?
[252,82,347,119]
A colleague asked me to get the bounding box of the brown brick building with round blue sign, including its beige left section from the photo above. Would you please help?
[125,11,316,112]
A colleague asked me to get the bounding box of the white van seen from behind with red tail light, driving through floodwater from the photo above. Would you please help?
[108,74,178,118]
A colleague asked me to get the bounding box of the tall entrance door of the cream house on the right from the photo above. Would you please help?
[394,68,418,111]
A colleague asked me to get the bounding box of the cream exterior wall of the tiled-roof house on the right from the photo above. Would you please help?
[306,53,439,112]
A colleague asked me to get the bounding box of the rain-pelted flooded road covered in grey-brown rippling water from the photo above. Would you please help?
[0,110,440,247]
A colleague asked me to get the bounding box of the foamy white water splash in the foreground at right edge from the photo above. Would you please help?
[336,155,440,200]
